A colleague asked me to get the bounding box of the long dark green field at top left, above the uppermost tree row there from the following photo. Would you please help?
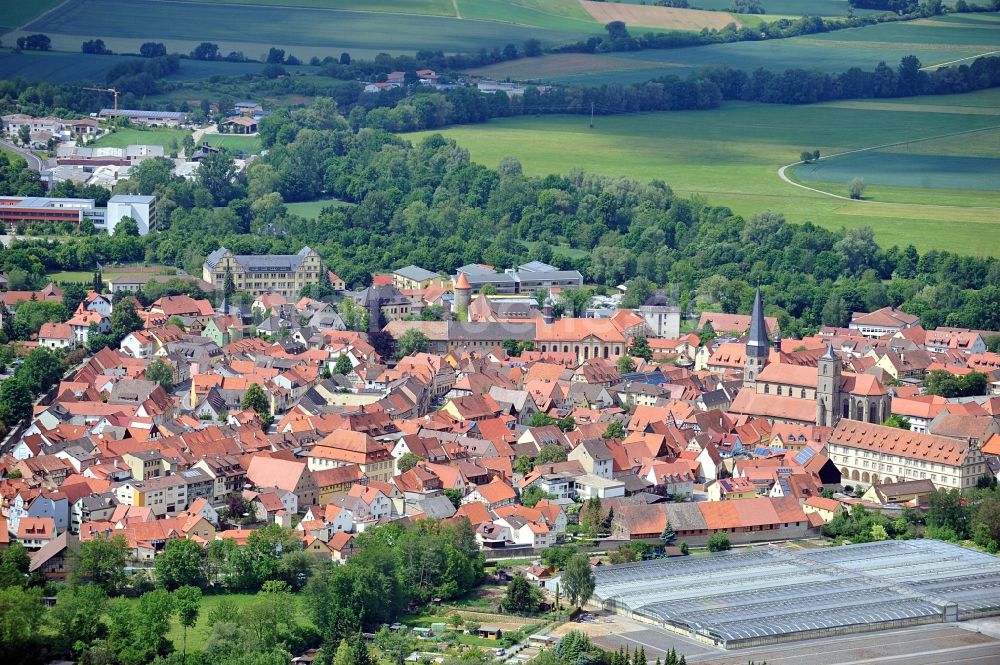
[17,0,602,59]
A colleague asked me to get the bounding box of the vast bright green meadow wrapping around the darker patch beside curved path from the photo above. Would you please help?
[410,91,1000,254]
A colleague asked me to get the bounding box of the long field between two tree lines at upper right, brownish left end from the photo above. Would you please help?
[468,14,1000,85]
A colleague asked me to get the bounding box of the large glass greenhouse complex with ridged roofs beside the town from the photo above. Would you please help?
[594,540,1000,648]
